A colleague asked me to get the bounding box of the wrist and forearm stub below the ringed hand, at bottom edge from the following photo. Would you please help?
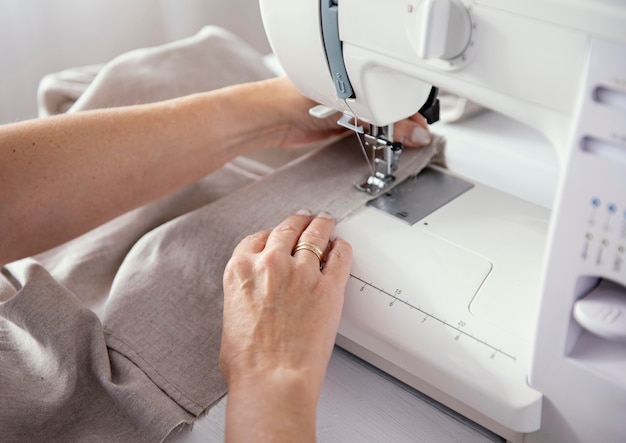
[226,372,318,443]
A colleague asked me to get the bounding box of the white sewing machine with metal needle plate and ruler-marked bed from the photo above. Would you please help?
[260,0,626,443]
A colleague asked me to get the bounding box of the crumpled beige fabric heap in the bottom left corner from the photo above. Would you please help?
[0,261,193,442]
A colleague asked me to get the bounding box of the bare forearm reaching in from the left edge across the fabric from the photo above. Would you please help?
[0,79,292,264]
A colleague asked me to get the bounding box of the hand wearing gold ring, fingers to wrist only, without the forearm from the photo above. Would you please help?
[220,211,352,383]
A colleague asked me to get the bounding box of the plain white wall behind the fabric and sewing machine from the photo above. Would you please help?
[0,0,269,124]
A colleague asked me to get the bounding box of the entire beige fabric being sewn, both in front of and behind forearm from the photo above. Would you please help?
[0,24,444,442]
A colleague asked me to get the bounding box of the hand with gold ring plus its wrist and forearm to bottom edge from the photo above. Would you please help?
[220,211,352,441]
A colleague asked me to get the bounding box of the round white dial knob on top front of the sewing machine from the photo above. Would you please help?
[416,0,472,60]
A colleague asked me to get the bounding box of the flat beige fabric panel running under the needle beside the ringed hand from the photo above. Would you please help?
[104,137,441,414]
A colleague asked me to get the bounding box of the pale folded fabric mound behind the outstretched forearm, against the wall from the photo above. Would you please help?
[37,26,274,116]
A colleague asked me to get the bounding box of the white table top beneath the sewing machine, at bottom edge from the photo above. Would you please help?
[168,348,501,443]
